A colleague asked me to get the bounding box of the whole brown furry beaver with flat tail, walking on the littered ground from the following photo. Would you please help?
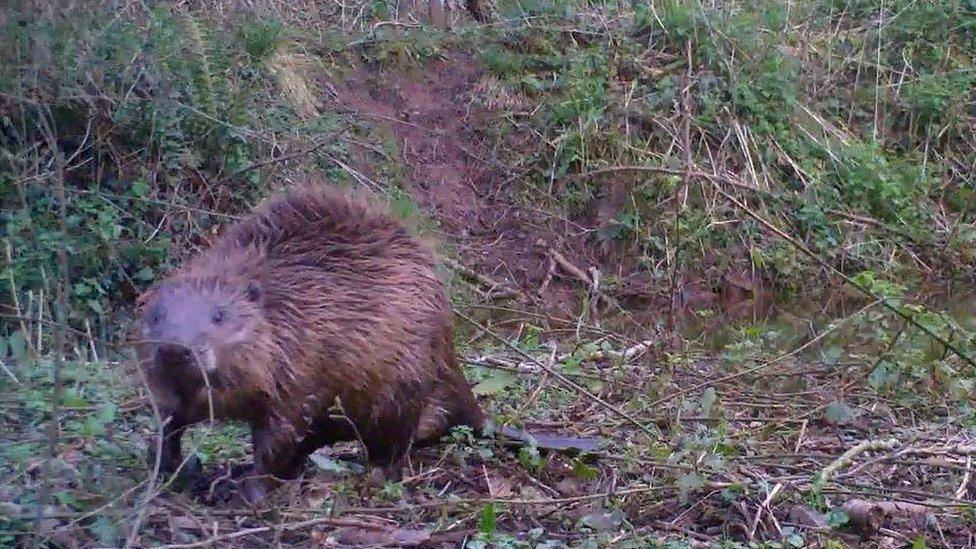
[137,182,600,503]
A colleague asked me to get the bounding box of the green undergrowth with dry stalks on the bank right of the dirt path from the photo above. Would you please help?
[468,1,976,288]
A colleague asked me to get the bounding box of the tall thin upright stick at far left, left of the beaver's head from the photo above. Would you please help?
[34,104,69,547]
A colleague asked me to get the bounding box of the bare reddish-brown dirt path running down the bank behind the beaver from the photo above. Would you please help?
[339,54,580,306]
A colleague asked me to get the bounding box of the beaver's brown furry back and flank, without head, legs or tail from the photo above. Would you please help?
[185,185,450,415]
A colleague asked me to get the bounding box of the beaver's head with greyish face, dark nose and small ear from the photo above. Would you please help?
[138,279,267,383]
